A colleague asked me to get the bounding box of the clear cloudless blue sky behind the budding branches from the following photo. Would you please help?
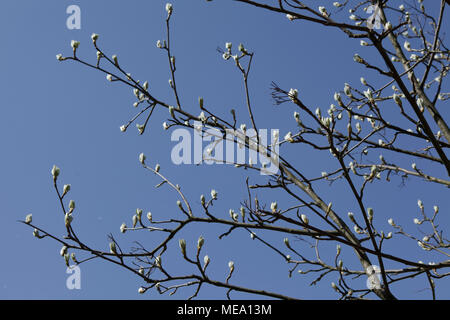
[0,0,450,299]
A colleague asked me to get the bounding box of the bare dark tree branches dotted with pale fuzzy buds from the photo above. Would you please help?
[23,0,450,300]
